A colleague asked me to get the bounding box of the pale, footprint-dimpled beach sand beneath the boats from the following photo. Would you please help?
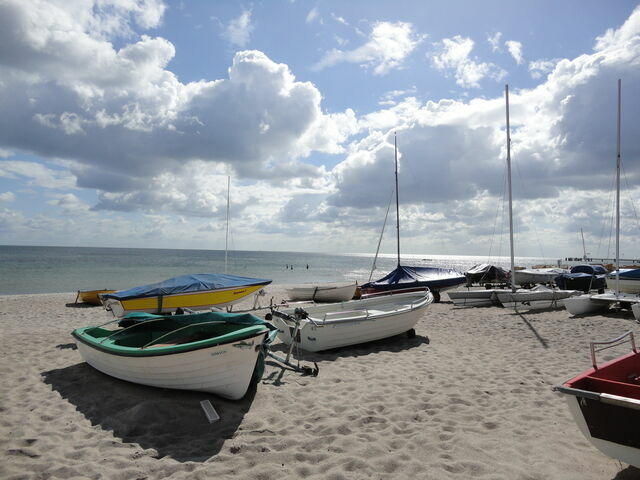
[0,285,640,480]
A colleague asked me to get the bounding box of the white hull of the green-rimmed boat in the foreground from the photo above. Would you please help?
[76,333,266,400]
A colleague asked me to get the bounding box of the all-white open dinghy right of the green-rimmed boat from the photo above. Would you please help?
[271,290,433,352]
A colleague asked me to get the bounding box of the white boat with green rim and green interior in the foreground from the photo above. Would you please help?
[72,312,276,400]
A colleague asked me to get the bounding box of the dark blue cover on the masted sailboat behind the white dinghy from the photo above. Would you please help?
[362,265,466,291]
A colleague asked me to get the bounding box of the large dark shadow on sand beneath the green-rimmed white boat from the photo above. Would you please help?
[42,363,256,462]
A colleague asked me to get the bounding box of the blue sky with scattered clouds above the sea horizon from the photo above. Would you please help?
[0,0,640,258]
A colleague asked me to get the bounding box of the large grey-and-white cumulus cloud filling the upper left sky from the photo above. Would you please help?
[0,2,354,192]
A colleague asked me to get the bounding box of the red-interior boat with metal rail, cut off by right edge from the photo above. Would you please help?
[554,331,640,468]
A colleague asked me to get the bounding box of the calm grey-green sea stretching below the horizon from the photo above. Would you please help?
[0,245,557,295]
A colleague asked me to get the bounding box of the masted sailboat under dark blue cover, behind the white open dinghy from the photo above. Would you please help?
[360,135,466,302]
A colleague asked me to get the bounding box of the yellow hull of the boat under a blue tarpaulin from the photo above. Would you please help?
[103,283,268,317]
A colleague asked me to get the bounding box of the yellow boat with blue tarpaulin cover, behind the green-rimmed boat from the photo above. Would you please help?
[101,273,271,317]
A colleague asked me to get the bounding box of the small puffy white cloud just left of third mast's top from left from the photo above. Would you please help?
[431,35,506,88]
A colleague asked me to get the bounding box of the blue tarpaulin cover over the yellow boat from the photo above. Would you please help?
[102,273,271,300]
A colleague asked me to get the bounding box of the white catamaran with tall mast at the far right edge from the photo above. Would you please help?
[564,80,640,315]
